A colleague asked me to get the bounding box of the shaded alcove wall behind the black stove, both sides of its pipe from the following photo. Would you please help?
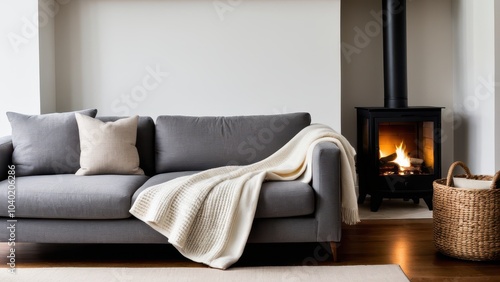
[342,0,454,171]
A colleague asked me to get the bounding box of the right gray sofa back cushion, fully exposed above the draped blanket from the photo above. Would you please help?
[156,113,311,173]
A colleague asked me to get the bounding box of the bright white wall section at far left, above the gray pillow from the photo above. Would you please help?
[0,0,40,136]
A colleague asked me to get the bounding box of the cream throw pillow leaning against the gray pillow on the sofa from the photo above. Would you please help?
[75,113,144,175]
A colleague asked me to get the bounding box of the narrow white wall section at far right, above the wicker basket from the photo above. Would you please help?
[453,0,500,174]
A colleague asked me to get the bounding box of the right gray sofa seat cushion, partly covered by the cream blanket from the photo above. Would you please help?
[132,171,315,218]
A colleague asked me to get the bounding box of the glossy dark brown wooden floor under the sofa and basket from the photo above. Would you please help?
[0,219,500,281]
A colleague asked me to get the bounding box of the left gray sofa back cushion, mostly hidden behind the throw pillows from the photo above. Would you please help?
[97,116,155,176]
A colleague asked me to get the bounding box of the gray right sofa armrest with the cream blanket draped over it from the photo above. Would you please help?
[312,142,342,242]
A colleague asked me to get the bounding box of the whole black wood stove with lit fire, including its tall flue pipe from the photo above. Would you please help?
[356,0,441,211]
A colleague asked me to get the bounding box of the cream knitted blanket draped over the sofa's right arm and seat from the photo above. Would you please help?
[130,124,359,269]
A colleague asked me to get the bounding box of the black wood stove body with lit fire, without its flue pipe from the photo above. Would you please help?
[357,107,441,211]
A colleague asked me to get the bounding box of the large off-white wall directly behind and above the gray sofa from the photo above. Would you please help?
[55,0,340,130]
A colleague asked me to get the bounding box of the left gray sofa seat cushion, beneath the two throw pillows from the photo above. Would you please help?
[0,174,149,219]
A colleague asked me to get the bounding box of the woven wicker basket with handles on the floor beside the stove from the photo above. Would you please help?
[433,162,500,261]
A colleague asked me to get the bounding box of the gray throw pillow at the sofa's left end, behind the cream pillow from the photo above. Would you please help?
[7,109,97,176]
